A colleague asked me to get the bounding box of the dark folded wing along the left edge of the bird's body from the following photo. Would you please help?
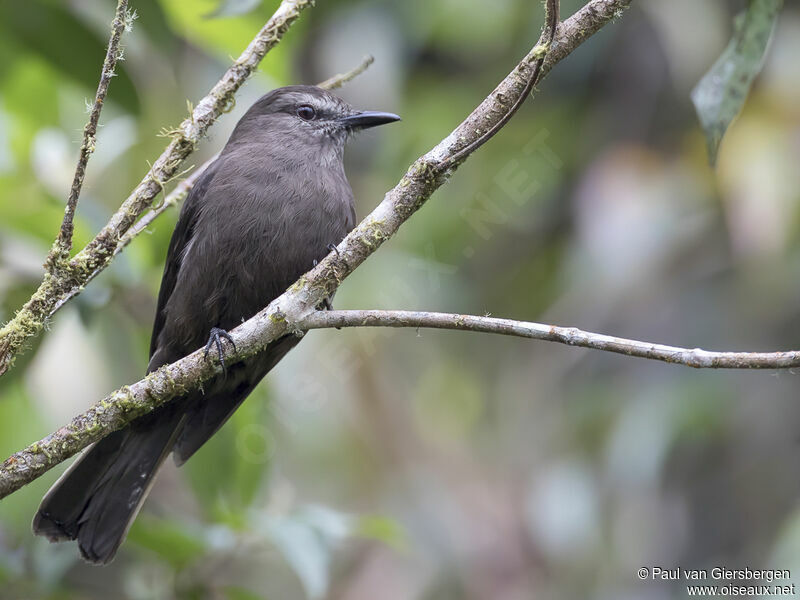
[148,161,219,371]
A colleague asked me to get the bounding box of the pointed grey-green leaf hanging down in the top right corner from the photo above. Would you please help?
[692,0,783,165]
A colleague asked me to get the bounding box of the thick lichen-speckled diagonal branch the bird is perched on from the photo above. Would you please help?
[0,0,631,498]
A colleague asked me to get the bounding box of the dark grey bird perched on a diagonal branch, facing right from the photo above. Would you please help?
[33,86,400,564]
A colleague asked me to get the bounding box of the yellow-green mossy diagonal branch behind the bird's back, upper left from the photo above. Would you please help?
[0,0,313,375]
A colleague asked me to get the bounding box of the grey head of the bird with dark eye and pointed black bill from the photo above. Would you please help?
[225,85,400,158]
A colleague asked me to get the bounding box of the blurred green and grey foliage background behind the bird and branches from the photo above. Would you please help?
[0,0,800,600]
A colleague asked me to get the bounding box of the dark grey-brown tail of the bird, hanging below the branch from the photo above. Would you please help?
[33,411,183,564]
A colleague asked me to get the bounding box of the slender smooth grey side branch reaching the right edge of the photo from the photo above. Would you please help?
[297,310,800,369]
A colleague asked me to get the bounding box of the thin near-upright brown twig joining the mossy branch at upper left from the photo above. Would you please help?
[48,0,133,270]
